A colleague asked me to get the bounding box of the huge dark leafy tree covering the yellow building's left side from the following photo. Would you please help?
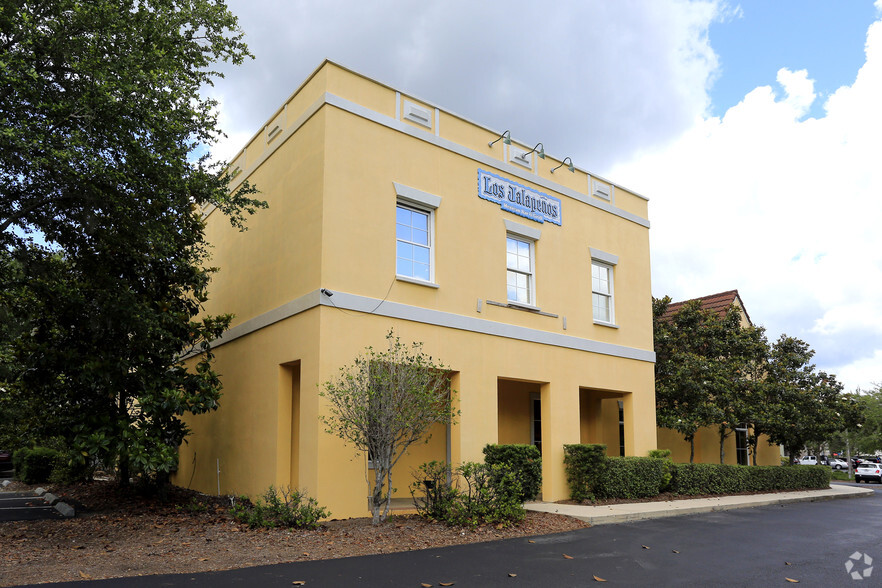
[0,0,265,483]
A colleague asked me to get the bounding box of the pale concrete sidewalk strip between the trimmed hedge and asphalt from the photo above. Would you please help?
[524,484,875,525]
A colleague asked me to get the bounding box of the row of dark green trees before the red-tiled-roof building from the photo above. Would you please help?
[653,297,862,463]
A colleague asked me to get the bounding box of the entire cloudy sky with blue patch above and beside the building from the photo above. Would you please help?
[212,0,882,390]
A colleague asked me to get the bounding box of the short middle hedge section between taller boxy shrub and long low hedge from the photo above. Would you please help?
[595,457,670,498]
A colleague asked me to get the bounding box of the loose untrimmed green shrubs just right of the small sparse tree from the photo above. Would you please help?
[410,461,526,527]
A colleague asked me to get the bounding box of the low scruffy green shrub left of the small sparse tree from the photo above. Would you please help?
[231,486,331,529]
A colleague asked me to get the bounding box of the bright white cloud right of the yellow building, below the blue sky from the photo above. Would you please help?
[612,14,882,388]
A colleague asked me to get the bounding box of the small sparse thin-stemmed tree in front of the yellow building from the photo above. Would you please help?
[321,331,454,525]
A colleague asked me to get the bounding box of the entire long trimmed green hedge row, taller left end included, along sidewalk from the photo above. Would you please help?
[564,445,832,502]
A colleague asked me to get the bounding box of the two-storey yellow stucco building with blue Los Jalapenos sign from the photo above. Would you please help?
[175,62,656,517]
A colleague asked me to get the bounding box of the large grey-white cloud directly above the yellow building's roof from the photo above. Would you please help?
[214,0,728,173]
